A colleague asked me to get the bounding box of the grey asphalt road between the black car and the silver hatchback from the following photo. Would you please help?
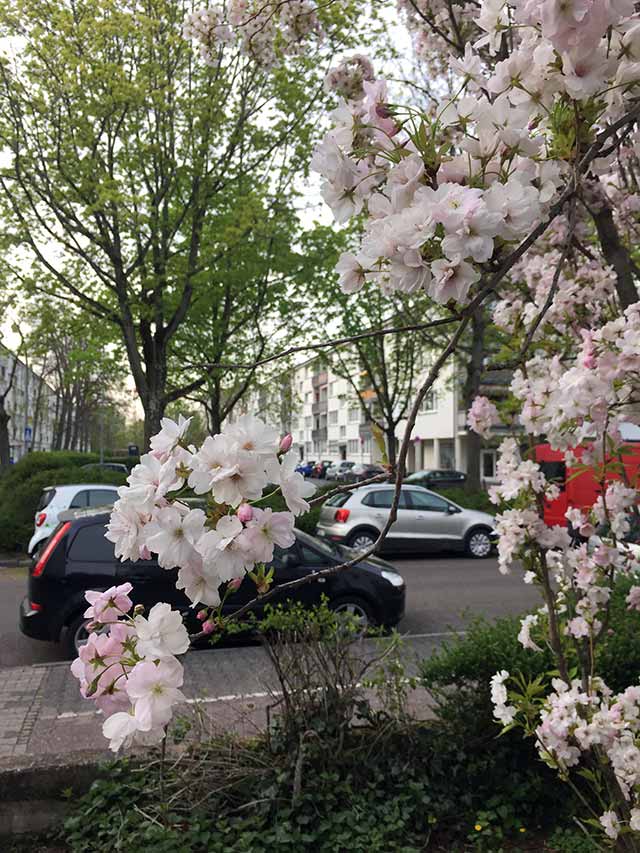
[0,555,538,666]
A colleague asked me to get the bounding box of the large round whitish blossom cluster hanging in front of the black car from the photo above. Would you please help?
[107,415,314,607]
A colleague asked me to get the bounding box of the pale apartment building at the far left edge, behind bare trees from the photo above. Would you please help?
[0,344,57,462]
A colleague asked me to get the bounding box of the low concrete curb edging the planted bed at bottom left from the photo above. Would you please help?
[0,751,113,838]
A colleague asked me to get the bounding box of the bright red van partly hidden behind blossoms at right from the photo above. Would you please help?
[535,442,640,527]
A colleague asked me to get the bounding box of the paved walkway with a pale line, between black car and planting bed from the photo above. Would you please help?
[0,635,444,769]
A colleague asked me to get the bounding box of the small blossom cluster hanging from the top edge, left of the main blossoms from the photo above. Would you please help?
[183,0,322,67]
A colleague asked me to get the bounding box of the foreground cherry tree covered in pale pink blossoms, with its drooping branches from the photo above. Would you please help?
[70,0,640,850]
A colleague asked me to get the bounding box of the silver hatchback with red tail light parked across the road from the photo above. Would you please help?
[317,483,497,558]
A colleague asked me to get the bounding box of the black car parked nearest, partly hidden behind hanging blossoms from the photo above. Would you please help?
[20,511,405,656]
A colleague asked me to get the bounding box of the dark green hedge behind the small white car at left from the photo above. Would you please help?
[0,451,126,551]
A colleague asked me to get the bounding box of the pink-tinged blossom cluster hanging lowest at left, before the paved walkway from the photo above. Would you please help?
[71,583,189,751]
